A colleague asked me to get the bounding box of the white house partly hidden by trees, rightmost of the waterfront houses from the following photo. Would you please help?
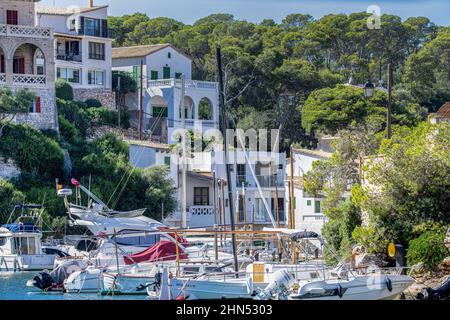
[285,148,331,234]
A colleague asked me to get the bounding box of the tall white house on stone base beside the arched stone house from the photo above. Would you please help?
[36,0,115,108]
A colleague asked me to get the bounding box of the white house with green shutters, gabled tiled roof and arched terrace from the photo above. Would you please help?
[112,43,219,143]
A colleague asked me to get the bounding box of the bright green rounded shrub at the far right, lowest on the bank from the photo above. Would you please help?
[406,230,447,270]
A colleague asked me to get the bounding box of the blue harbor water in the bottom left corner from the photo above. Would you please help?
[0,271,142,300]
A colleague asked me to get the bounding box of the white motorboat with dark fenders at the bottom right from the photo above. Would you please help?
[288,273,414,300]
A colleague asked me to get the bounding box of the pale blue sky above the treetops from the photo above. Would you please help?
[41,0,450,26]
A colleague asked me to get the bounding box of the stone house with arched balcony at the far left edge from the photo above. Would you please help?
[0,0,58,130]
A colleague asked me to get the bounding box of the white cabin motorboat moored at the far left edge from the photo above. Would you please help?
[0,205,55,271]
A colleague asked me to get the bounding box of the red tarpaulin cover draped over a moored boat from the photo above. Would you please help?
[123,241,188,264]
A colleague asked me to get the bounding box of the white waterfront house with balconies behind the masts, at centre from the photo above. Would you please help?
[130,142,286,228]
